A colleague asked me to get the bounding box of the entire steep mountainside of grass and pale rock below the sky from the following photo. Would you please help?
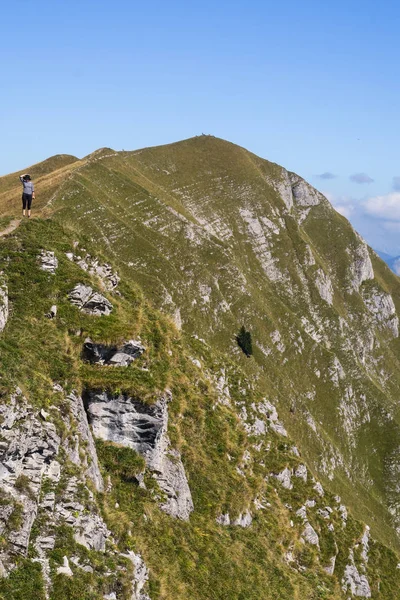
[0,136,400,600]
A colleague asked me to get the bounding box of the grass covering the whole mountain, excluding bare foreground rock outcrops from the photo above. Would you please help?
[0,136,400,600]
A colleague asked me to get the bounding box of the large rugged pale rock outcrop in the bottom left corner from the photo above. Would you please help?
[0,385,150,600]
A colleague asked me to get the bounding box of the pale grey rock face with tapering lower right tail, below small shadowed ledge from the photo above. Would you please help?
[84,392,193,520]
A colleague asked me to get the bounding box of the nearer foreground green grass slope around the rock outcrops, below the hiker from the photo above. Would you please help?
[0,218,400,600]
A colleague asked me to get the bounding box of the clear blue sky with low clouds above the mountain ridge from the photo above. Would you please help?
[0,0,400,254]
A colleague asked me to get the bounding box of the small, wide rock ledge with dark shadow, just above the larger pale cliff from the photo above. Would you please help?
[82,338,145,367]
